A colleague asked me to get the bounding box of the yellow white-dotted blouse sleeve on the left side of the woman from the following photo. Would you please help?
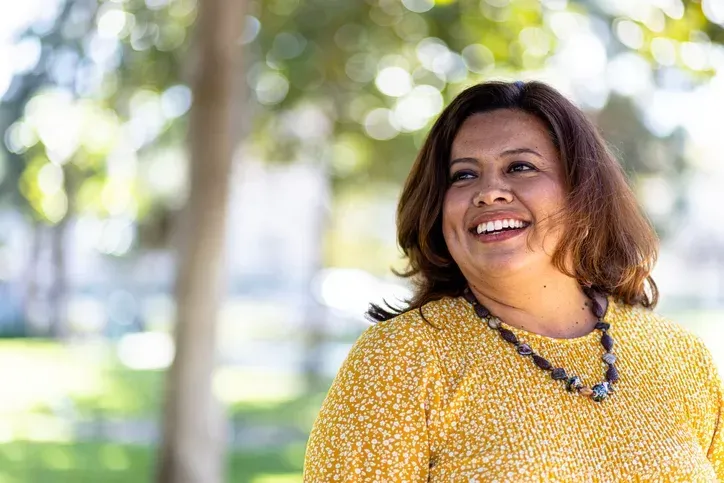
[304,316,439,483]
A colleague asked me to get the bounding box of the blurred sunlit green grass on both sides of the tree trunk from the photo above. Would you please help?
[0,339,324,483]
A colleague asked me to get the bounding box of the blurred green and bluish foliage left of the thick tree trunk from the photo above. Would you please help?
[0,0,196,236]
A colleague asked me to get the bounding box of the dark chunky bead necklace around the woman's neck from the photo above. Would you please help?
[463,287,619,402]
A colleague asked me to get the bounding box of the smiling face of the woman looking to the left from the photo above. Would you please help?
[442,109,566,280]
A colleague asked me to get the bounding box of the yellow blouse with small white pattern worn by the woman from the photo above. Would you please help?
[304,298,724,482]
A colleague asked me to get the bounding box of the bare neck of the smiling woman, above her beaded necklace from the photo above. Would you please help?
[468,270,606,339]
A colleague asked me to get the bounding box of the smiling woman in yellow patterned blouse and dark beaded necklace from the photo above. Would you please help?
[304,82,724,482]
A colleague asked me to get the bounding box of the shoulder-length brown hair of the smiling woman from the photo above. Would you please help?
[367,82,658,321]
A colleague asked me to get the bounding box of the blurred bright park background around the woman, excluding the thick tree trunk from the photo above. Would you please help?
[0,0,724,483]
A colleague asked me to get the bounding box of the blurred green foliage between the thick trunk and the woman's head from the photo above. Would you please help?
[247,0,552,187]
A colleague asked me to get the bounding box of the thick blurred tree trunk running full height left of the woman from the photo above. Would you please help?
[158,0,245,483]
